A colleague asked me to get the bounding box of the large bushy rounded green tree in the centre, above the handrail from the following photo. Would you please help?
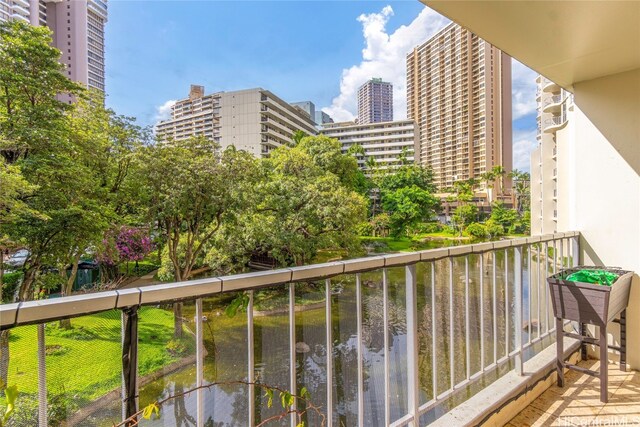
[220,136,366,266]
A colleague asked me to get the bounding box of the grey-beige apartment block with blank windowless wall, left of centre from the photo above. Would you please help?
[156,85,317,157]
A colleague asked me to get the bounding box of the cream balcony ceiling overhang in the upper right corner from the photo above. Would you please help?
[421,0,640,90]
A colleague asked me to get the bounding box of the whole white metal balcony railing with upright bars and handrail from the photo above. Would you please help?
[0,232,579,427]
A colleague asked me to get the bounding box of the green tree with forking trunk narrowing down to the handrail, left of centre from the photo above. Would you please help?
[139,137,257,281]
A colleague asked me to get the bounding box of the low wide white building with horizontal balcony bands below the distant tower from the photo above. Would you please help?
[321,120,418,171]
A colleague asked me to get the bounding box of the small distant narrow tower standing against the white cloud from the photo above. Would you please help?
[358,79,393,124]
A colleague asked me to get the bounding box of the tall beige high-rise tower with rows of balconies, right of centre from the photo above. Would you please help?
[407,23,512,194]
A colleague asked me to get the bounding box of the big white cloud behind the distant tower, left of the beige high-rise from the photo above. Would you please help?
[322,6,450,121]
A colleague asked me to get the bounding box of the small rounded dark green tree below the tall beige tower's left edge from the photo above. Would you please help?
[382,185,439,236]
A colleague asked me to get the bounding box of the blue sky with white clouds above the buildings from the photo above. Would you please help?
[106,0,535,169]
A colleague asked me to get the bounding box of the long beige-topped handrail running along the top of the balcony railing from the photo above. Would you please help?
[0,232,579,330]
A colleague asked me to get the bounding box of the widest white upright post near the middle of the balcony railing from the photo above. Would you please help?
[405,264,420,427]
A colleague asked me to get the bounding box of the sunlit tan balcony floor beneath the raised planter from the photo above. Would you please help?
[507,360,640,427]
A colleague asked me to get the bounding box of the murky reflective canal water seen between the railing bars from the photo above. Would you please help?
[81,249,552,427]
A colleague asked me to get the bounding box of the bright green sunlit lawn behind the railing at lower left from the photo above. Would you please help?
[8,307,188,406]
